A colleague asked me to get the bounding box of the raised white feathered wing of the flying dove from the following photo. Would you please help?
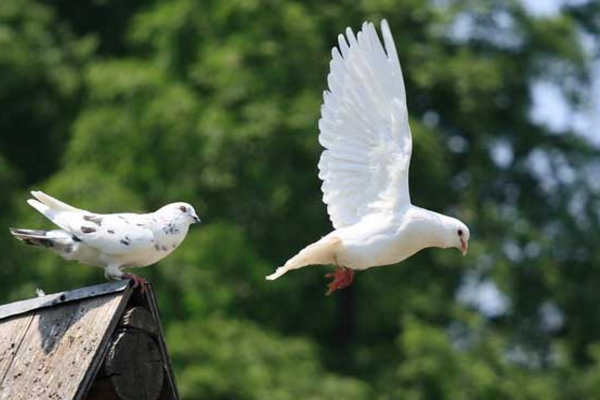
[319,20,412,229]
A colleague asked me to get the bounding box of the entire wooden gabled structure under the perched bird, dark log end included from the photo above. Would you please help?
[0,282,179,400]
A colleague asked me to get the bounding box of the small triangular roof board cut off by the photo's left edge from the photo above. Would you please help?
[0,315,33,393]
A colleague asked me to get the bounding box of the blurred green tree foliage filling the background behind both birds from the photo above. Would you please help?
[0,0,600,400]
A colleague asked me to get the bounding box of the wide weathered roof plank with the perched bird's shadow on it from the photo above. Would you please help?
[0,293,128,400]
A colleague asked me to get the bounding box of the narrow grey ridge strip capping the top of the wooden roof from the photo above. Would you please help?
[0,280,129,320]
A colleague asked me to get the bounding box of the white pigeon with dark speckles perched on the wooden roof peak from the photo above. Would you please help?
[10,192,200,287]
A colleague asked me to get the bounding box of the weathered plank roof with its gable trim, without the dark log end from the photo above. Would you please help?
[0,281,179,400]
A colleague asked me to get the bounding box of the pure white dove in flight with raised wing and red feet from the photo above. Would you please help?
[267,20,469,294]
